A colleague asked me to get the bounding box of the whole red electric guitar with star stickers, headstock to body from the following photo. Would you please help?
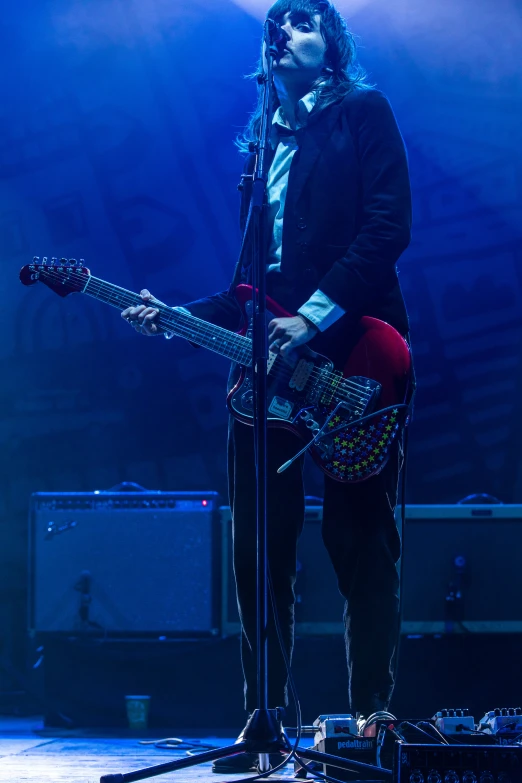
[20,258,411,483]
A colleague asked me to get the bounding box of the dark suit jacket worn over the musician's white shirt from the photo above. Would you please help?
[185,89,411,350]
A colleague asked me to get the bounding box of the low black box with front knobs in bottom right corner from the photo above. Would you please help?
[394,743,522,783]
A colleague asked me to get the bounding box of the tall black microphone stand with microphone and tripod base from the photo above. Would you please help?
[100,19,392,783]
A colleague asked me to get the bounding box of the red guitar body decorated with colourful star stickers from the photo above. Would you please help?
[227,285,412,483]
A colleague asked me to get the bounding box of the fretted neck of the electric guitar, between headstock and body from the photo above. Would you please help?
[83,276,252,366]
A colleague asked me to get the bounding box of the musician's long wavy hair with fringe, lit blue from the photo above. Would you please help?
[236,0,372,153]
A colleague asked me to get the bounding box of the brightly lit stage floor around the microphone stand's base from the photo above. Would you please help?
[0,718,300,783]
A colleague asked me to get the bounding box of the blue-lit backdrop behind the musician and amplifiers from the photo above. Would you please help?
[0,0,522,680]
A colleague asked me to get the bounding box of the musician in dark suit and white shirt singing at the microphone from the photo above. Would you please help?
[122,0,411,772]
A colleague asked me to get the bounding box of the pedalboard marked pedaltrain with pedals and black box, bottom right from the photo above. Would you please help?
[295,707,522,783]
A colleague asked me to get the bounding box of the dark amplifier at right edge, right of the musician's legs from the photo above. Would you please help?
[397,504,522,634]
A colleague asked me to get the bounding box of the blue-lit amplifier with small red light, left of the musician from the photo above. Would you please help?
[29,491,219,635]
